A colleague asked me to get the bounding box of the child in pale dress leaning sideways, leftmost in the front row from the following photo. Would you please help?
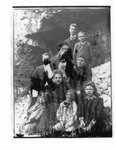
[21,92,48,135]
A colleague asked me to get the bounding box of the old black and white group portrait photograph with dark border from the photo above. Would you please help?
[12,6,113,138]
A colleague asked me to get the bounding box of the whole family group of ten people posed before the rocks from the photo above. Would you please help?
[20,23,104,137]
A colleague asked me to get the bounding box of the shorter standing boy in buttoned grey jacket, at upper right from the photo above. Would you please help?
[73,31,92,66]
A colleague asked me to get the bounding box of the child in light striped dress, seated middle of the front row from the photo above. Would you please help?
[53,89,77,137]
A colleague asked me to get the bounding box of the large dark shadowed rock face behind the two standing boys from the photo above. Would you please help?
[26,7,110,66]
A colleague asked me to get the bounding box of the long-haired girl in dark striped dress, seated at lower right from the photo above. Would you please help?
[81,81,103,136]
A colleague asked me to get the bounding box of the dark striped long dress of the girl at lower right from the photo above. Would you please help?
[81,97,103,136]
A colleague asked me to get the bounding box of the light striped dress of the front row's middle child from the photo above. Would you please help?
[54,101,77,131]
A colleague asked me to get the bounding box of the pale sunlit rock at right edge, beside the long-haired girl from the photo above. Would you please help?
[92,62,112,108]
